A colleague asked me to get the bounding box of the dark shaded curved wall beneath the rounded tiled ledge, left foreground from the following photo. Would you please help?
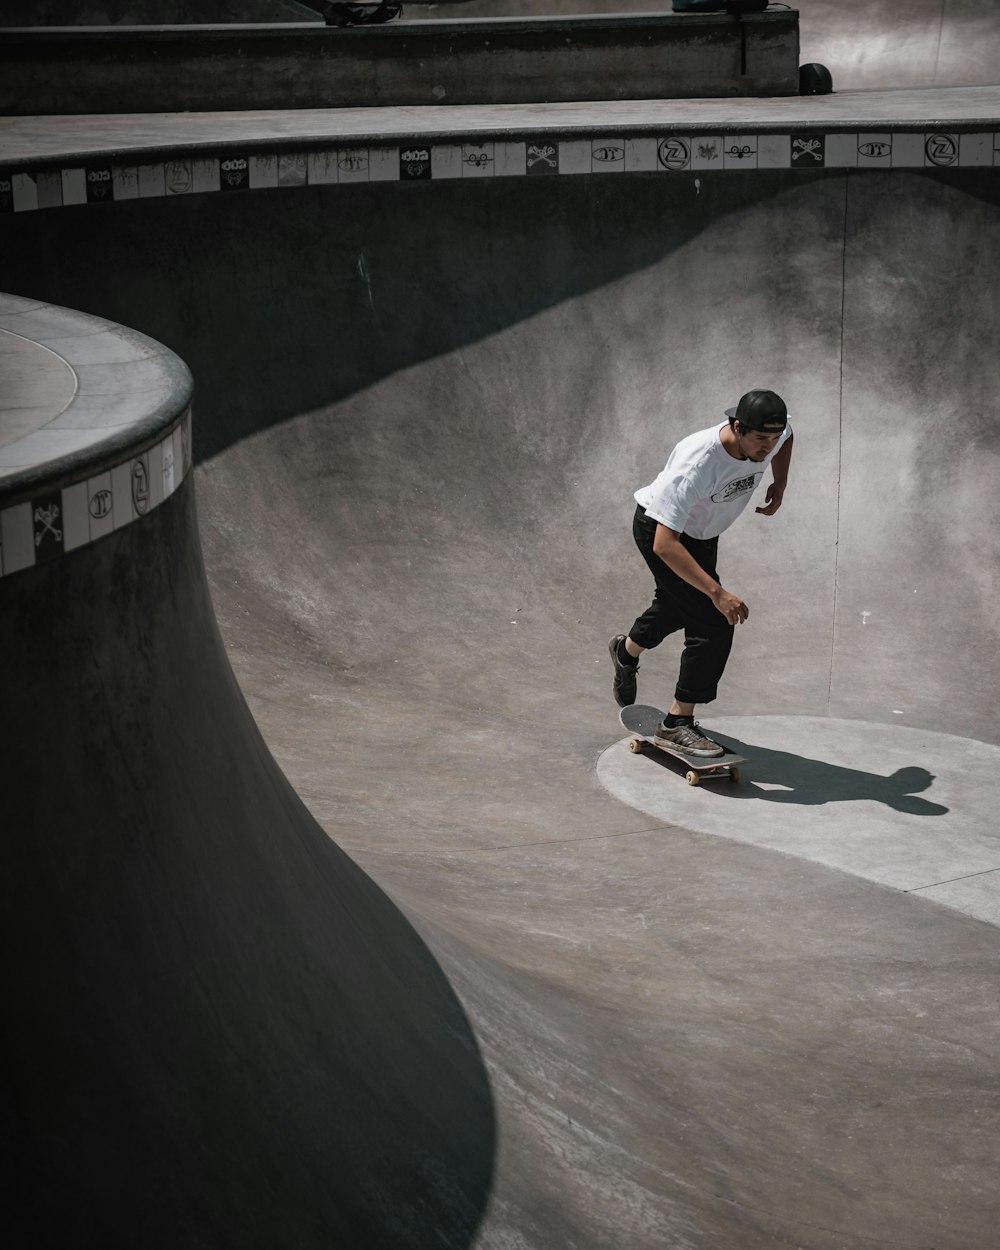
[0,481,496,1250]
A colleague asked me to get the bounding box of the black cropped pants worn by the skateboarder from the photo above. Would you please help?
[629,508,734,703]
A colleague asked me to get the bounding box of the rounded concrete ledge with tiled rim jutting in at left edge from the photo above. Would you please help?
[0,295,193,576]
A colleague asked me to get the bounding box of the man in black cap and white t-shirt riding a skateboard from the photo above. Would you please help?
[608,390,791,756]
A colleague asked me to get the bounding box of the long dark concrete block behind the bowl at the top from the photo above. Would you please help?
[0,10,799,116]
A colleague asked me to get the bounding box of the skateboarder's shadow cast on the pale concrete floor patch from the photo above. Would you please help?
[658,733,950,816]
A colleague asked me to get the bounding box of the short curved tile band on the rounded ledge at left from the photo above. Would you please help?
[0,408,191,576]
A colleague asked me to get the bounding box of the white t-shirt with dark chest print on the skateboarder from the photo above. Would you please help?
[635,421,791,539]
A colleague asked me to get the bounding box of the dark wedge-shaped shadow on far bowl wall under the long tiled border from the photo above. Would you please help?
[0,170,844,460]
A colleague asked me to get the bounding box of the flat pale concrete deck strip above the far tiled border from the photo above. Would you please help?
[0,86,1000,171]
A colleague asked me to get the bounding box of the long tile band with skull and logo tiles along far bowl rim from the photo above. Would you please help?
[0,129,1000,213]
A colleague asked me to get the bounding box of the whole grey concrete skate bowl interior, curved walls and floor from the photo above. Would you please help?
[0,115,1000,1250]
